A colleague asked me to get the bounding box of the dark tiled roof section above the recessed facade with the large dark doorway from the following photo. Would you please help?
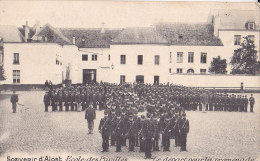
[60,28,122,48]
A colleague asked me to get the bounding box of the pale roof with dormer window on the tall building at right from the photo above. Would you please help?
[213,10,260,30]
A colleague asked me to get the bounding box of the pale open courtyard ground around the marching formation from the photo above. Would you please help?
[0,91,260,161]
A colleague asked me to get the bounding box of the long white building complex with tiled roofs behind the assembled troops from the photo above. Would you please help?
[0,10,260,84]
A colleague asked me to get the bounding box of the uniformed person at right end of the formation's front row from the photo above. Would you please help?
[179,113,190,151]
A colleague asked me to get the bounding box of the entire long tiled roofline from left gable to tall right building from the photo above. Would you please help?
[32,23,222,48]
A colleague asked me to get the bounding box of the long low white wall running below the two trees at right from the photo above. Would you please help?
[169,74,260,89]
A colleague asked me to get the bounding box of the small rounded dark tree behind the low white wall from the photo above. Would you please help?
[209,56,227,74]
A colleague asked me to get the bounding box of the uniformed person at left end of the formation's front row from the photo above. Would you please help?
[98,111,111,152]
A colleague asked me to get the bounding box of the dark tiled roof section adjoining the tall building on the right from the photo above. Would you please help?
[156,23,222,46]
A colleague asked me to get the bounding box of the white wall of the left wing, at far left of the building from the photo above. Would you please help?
[0,43,62,84]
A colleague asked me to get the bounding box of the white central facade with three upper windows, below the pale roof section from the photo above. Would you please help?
[110,44,169,83]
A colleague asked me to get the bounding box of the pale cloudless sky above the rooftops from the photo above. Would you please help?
[0,0,260,28]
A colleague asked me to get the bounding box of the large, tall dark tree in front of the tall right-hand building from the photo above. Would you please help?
[230,37,259,74]
